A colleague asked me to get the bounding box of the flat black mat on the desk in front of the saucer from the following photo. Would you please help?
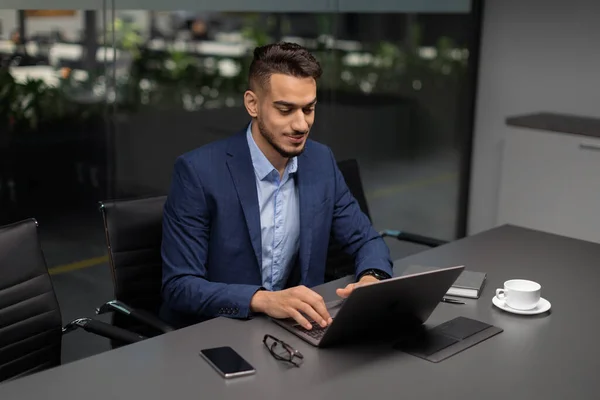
[394,317,503,362]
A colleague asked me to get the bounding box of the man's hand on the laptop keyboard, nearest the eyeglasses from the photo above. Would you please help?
[250,286,333,329]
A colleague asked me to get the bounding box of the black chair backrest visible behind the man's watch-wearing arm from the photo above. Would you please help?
[325,159,371,282]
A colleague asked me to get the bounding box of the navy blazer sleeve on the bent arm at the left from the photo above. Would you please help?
[161,157,260,318]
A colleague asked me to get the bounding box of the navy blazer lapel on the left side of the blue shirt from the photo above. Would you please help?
[227,131,262,268]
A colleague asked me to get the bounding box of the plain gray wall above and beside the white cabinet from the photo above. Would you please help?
[468,0,600,234]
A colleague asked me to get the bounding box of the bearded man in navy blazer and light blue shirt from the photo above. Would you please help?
[161,43,392,329]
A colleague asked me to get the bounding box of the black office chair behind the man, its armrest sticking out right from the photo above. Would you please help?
[325,159,446,282]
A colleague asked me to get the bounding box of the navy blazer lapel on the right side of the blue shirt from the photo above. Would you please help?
[296,152,317,284]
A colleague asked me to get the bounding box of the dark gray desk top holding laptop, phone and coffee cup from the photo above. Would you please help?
[0,226,600,400]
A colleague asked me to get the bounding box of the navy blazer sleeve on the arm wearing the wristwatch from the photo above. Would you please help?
[329,150,394,277]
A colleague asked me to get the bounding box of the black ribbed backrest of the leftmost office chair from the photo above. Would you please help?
[0,219,62,381]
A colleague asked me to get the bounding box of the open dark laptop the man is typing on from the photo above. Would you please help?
[273,265,464,347]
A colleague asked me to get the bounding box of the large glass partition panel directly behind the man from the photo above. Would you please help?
[113,0,474,244]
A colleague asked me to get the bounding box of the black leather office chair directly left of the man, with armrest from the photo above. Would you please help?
[96,196,173,347]
